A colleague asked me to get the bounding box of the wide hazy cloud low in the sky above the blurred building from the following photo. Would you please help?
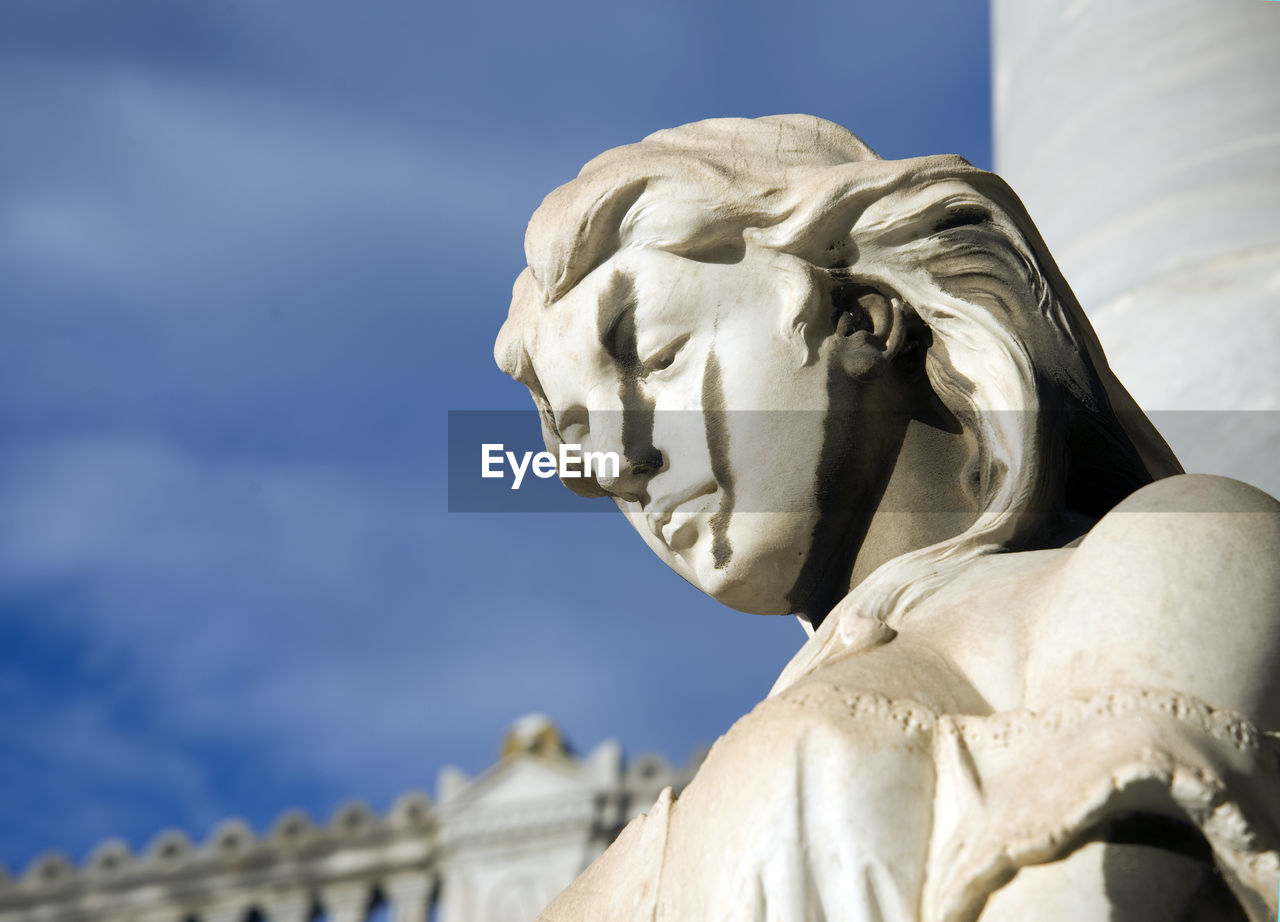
[0,437,680,784]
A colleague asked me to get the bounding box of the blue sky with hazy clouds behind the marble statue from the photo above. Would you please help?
[0,0,991,872]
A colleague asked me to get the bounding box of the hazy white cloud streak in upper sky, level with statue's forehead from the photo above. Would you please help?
[0,58,560,312]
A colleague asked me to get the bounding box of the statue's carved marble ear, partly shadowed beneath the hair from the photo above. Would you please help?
[831,282,918,380]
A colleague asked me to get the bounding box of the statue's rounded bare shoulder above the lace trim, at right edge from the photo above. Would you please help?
[1028,475,1280,726]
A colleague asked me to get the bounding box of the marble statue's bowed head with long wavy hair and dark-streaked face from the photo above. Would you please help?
[495,115,1178,627]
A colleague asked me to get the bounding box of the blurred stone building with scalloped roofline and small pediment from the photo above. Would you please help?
[0,715,700,922]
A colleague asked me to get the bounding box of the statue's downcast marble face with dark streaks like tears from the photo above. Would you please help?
[530,247,870,613]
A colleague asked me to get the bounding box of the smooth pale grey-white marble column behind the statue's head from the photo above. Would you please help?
[992,0,1280,493]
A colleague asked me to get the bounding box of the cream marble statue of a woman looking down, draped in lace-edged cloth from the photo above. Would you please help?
[495,115,1280,922]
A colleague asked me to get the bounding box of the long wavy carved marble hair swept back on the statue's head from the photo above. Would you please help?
[495,115,1180,630]
